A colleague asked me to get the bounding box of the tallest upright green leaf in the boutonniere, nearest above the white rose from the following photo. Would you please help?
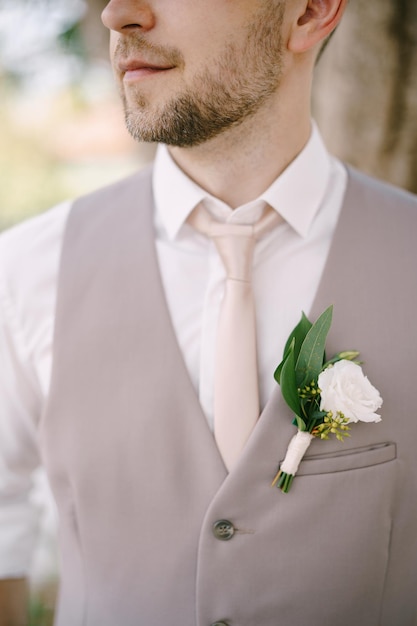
[295,306,333,388]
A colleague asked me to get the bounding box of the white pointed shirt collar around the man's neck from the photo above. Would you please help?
[153,123,331,239]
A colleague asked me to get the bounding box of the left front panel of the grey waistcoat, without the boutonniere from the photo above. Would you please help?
[40,166,226,626]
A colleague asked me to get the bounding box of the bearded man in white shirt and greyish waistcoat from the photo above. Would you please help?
[0,0,417,626]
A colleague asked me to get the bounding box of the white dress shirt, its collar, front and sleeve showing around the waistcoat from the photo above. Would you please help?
[0,126,347,578]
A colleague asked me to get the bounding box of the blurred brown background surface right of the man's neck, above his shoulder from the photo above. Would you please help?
[313,0,417,192]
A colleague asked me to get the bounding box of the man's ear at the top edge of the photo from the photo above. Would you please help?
[287,0,348,53]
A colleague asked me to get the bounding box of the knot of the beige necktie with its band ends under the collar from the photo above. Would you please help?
[188,204,281,282]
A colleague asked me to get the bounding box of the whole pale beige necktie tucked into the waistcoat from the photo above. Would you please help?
[188,205,282,470]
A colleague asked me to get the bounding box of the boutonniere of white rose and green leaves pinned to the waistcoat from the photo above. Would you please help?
[272,306,382,493]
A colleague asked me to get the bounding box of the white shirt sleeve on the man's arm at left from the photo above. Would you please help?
[0,201,72,578]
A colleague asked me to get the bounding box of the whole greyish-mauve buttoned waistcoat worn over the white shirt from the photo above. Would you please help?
[40,166,417,626]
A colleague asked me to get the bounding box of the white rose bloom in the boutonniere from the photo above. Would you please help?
[318,360,382,422]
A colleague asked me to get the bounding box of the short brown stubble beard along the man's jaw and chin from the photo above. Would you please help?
[118,1,283,147]
